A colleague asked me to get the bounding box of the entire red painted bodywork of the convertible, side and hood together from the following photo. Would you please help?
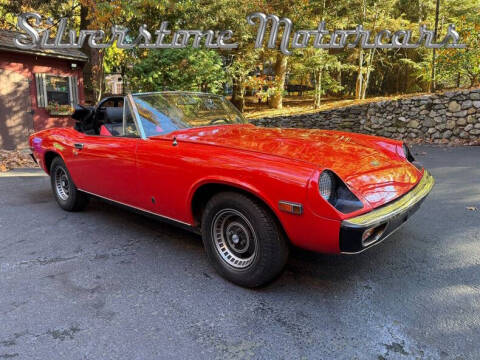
[30,119,422,253]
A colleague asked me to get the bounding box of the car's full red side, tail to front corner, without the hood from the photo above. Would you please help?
[31,125,346,252]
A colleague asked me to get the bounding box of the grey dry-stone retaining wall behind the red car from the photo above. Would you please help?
[251,89,480,142]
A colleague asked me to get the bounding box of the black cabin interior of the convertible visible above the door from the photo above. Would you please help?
[72,96,124,136]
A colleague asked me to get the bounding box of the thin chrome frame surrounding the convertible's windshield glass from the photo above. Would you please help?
[126,91,248,140]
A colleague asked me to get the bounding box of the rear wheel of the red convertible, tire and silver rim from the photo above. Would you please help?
[50,156,88,211]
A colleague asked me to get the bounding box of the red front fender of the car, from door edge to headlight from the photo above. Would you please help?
[137,139,340,252]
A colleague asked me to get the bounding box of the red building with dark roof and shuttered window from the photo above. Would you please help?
[0,30,88,150]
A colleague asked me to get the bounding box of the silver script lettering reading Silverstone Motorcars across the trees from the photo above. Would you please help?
[14,12,466,55]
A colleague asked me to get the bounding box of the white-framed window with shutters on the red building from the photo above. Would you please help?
[35,74,78,107]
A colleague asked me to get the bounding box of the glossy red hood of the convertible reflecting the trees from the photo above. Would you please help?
[169,125,422,207]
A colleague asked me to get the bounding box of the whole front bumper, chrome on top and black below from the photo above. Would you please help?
[340,170,435,254]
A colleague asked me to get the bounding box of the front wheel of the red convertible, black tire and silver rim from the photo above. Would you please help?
[201,192,289,288]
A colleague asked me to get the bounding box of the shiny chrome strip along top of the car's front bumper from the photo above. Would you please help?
[343,170,435,227]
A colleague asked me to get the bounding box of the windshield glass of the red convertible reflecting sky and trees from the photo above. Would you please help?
[133,92,246,137]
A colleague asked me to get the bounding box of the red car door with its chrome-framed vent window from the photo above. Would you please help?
[69,101,142,206]
